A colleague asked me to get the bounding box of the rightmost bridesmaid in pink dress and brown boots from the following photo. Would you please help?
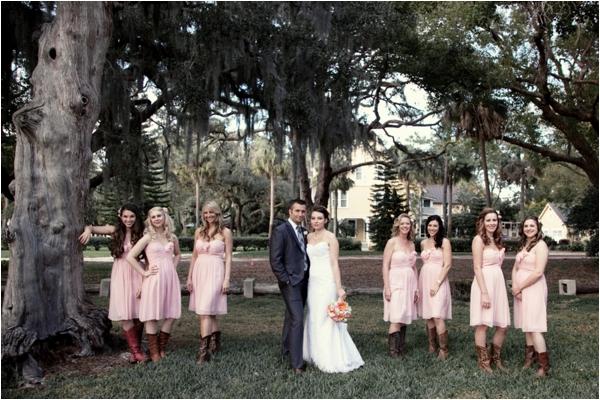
[512,217,550,377]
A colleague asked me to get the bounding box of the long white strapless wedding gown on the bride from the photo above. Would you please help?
[302,242,364,372]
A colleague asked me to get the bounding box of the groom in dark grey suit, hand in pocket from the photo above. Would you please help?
[269,199,309,374]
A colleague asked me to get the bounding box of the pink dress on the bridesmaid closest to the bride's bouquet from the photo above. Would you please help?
[383,251,418,324]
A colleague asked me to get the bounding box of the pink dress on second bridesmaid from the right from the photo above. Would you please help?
[470,248,510,328]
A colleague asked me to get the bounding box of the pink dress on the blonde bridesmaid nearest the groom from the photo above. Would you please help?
[189,239,227,315]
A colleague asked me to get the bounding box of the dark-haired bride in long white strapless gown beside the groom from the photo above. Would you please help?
[302,206,364,372]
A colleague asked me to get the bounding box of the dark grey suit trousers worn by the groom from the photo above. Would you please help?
[279,274,308,368]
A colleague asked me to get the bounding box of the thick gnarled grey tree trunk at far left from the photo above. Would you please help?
[2,2,111,382]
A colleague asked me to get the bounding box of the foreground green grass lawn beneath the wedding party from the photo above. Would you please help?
[2,295,598,398]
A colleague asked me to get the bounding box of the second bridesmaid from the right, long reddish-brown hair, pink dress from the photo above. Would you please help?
[470,208,510,373]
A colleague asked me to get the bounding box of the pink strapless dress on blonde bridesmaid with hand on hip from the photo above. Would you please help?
[140,240,181,322]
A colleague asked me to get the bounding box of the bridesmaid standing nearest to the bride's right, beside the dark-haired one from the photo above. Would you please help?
[381,214,419,358]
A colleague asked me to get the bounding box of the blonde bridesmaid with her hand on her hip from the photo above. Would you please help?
[127,207,181,362]
